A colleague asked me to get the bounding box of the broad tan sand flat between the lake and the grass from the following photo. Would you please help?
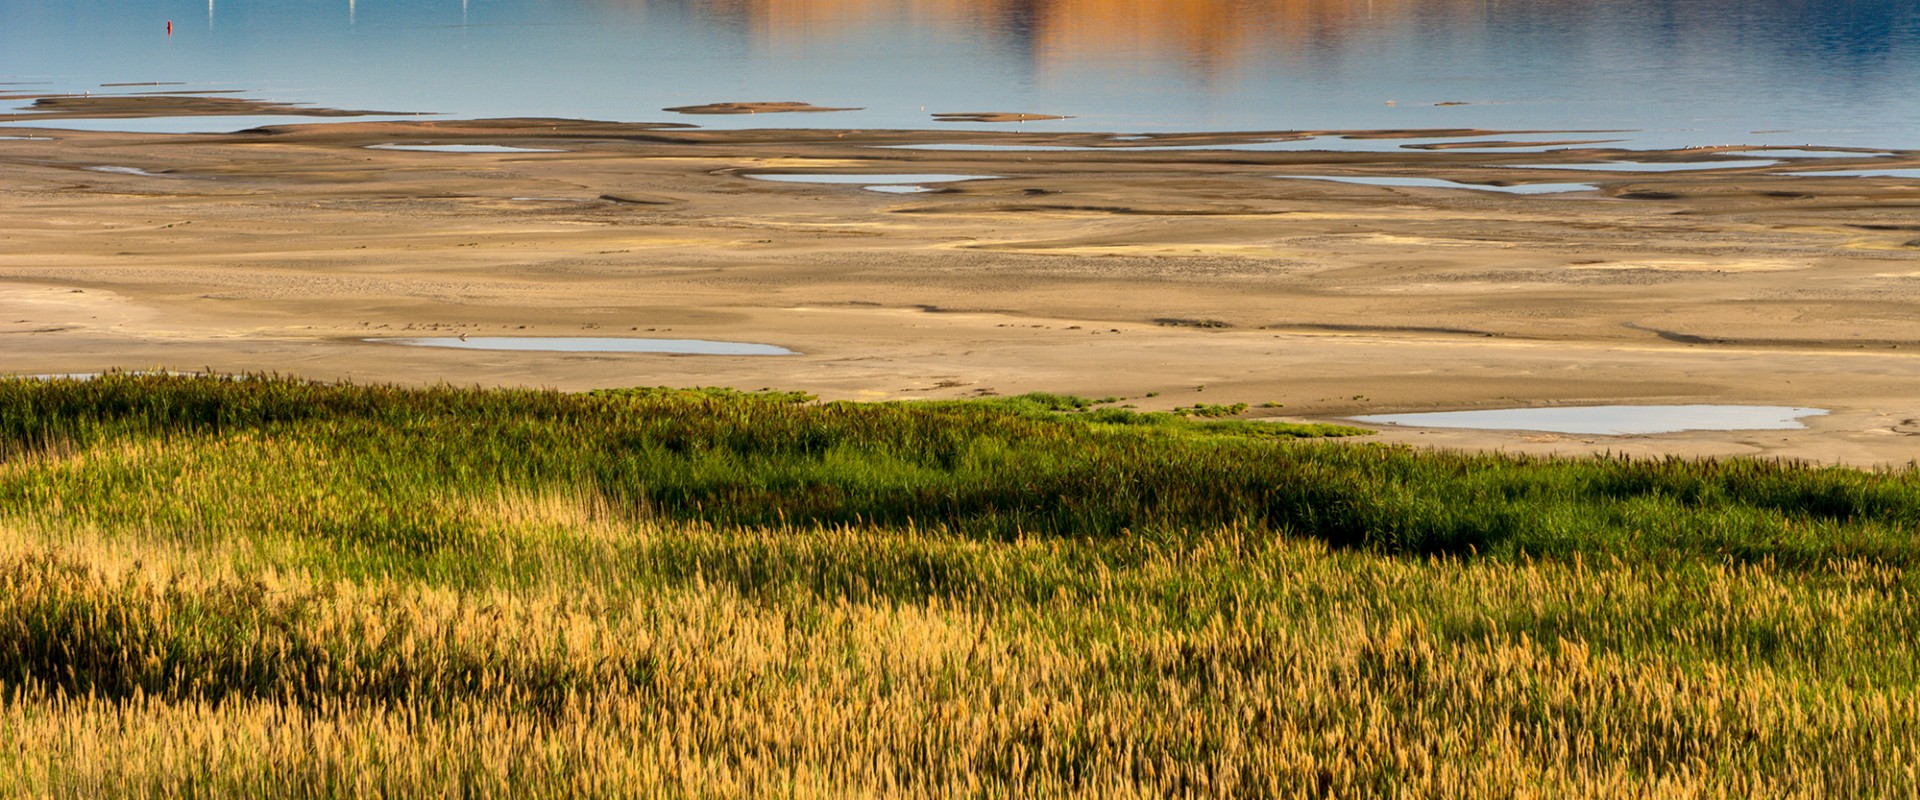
[0,111,1920,464]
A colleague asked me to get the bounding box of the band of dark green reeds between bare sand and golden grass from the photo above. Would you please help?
[0,376,1920,566]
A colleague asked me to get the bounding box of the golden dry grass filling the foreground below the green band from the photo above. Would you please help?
[0,499,1920,796]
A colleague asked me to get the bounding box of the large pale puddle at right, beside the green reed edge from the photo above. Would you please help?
[1350,405,1826,435]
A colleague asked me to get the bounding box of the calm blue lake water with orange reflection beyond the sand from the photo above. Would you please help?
[0,0,1920,148]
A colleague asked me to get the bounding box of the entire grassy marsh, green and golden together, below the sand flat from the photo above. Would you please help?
[0,376,1920,798]
